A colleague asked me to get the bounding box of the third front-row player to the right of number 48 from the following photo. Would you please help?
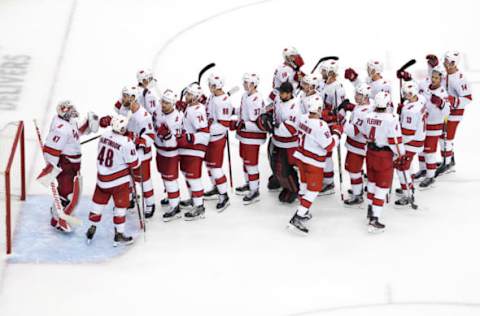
[177,83,210,220]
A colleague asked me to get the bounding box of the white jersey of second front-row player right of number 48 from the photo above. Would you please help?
[154,108,183,157]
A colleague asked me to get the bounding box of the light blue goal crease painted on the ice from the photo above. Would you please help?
[8,195,138,263]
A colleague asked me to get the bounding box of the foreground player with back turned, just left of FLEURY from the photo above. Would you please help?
[289,97,342,234]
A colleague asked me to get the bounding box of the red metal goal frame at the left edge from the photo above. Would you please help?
[4,121,26,255]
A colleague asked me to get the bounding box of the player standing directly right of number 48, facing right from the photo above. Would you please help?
[123,86,155,218]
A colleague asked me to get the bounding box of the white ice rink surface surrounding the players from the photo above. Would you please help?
[0,0,480,316]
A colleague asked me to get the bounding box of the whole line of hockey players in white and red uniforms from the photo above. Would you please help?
[39,47,472,245]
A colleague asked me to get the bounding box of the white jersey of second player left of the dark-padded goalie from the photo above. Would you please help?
[206,93,233,142]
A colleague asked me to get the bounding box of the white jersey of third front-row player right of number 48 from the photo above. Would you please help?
[178,104,210,159]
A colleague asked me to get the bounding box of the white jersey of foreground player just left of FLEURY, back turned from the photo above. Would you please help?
[293,114,338,168]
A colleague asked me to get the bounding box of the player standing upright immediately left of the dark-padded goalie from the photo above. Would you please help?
[234,73,267,204]
